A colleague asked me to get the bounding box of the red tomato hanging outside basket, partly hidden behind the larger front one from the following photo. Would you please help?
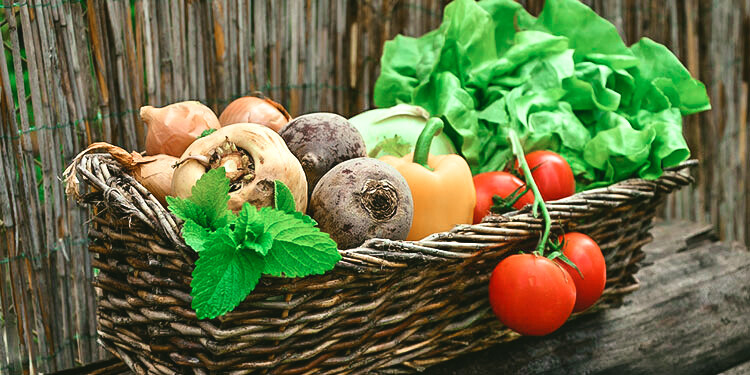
[555,232,607,312]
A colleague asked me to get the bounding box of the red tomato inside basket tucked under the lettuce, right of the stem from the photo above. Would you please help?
[516,151,576,202]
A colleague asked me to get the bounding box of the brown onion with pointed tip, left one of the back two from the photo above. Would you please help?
[141,101,221,157]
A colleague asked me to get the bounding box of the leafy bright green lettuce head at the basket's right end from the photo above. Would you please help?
[374,0,710,189]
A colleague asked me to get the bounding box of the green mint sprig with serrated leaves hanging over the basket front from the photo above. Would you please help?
[167,172,341,319]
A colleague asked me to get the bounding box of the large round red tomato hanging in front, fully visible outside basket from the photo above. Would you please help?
[489,254,576,336]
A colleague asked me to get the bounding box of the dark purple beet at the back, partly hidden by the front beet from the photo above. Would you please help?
[279,112,367,195]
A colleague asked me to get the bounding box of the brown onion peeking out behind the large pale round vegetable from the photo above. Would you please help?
[219,96,291,133]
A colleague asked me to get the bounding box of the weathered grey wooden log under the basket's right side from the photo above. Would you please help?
[426,226,750,375]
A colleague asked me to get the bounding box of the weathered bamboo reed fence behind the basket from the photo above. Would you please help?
[0,0,750,374]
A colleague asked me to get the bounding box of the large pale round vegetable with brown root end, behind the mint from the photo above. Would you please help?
[172,123,307,212]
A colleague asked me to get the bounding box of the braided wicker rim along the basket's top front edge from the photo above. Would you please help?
[71,153,698,272]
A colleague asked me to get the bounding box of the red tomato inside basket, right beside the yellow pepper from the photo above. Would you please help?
[474,172,534,224]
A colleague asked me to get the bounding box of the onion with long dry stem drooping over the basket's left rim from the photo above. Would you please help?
[64,142,178,207]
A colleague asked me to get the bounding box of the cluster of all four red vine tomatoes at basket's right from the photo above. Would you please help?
[474,151,607,336]
